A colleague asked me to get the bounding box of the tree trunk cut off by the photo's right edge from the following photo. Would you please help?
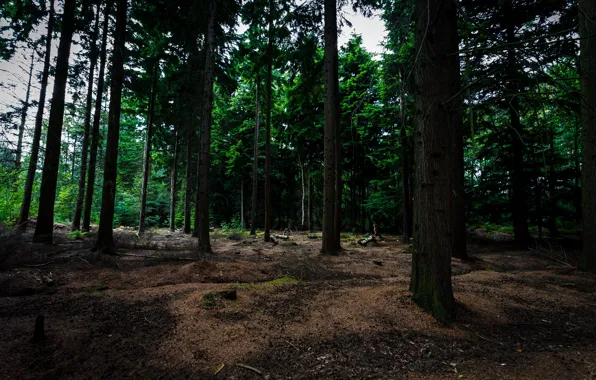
[578,0,596,273]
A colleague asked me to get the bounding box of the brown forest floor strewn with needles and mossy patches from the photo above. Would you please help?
[0,227,596,379]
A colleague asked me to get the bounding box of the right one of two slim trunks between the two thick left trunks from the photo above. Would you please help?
[82,0,112,232]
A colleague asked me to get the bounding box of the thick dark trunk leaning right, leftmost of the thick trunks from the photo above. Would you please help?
[33,0,76,243]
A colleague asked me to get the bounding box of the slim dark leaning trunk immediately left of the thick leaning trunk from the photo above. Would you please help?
[19,0,54,230]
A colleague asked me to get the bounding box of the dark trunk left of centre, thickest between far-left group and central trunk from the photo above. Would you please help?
[195,0,217,253]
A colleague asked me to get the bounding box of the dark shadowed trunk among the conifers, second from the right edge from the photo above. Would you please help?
[504,0,530,248]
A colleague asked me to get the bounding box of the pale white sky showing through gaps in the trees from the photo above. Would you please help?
[0,9,386,150]
